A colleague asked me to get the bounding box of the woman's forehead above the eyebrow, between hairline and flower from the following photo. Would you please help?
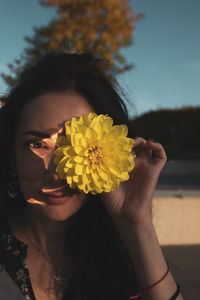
[19,93,94,134]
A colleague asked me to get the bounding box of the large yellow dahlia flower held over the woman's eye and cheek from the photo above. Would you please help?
[54,113,135,194]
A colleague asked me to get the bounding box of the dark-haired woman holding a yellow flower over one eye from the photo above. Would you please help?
[0,53,183,300]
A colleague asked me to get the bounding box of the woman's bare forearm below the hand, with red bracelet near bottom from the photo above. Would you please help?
[112,218,182,300]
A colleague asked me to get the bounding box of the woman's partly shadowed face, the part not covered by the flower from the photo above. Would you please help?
[14,92,94,221]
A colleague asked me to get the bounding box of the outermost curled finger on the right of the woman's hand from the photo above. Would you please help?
[147,140,167,167]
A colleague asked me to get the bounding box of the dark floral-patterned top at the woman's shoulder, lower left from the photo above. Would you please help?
[0,223,36,300]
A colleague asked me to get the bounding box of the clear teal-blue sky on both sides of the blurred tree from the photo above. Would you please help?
[0,0,200,116]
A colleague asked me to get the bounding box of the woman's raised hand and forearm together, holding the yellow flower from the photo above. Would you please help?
[101,137,183,300]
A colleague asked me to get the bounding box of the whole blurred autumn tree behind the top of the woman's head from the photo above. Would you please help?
[1,0,143,85]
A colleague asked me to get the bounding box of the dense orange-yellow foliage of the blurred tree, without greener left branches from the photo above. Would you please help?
[40,0,141,69]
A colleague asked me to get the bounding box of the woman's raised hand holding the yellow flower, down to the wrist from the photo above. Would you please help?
[101,137,166,224]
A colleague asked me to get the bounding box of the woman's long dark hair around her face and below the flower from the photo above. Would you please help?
[0,53,136,300]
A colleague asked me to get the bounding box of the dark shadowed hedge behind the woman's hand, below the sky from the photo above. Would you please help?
[130,106,200,159]
